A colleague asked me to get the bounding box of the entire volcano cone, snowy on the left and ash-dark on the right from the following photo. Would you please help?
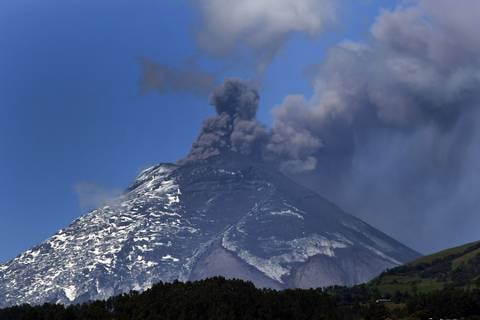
[0,153,418,307]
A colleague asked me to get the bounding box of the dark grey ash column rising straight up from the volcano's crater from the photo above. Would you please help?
[182,79,267,162]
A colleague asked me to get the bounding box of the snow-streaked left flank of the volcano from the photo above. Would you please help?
[0,166,198,304]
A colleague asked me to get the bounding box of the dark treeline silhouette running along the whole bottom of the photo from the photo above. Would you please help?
[0,277,480,320]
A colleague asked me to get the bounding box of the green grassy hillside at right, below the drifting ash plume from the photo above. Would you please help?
[369,241,480,295]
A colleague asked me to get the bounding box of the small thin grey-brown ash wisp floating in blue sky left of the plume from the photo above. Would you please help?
[139,58,216,95]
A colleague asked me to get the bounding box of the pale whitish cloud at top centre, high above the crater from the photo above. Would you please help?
[192,0,339,73]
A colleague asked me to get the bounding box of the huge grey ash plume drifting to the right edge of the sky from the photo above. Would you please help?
[269,0,480,251]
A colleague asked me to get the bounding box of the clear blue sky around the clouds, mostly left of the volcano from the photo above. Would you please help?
[0,0,402,261]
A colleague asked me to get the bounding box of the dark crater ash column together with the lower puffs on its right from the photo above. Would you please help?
[182,79,321,168]
